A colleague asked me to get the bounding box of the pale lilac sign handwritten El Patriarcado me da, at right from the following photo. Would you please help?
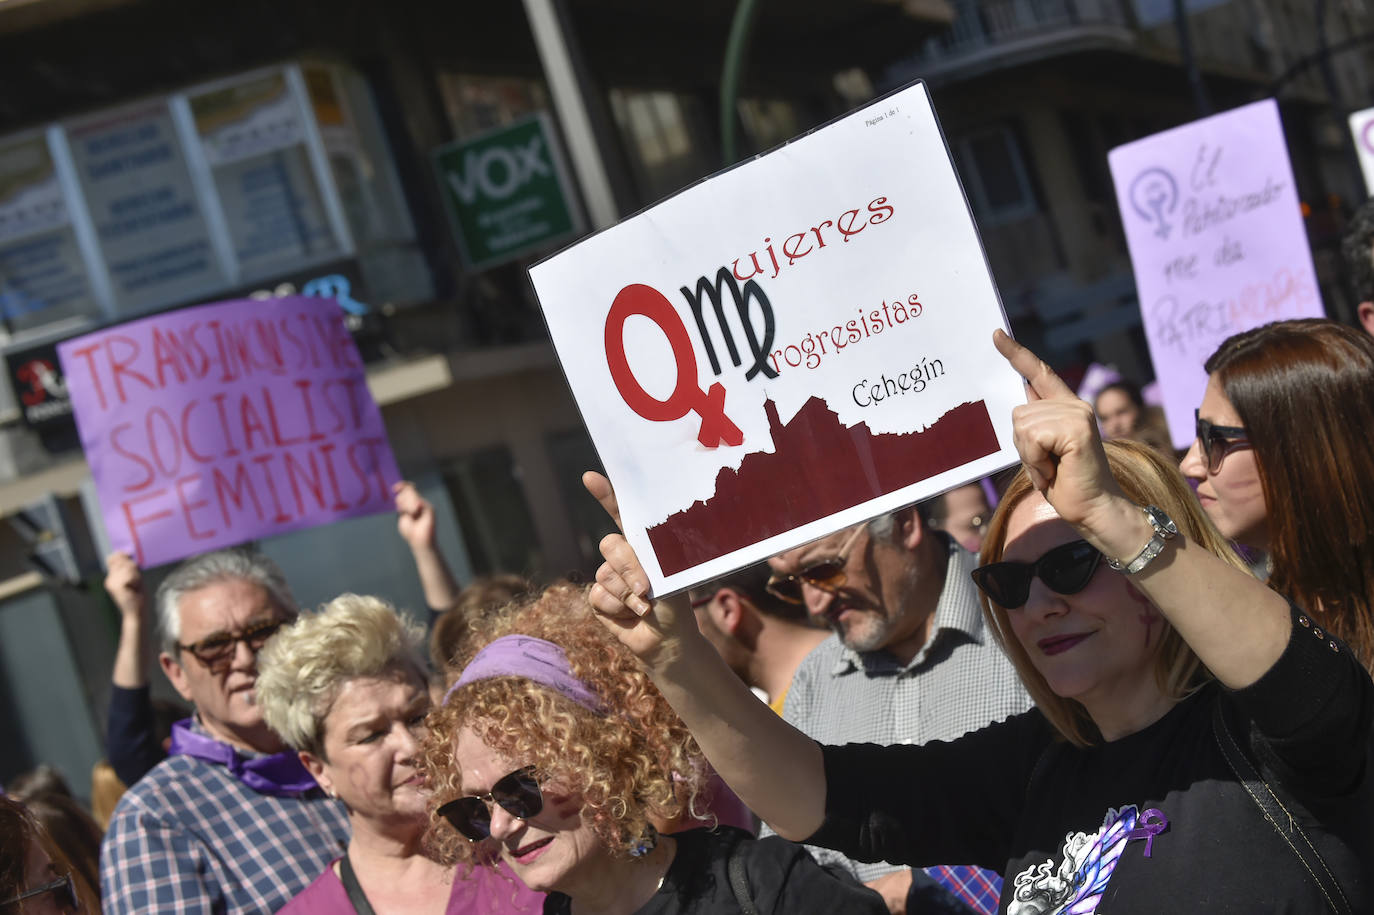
[1107,99,1322,448]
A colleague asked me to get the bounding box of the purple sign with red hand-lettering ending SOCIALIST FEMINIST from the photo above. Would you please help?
[58,298,400,566]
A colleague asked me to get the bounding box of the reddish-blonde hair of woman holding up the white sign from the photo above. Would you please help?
[978,438,1245,746]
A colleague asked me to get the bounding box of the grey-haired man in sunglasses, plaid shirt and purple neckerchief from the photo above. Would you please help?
[100,550,349,915]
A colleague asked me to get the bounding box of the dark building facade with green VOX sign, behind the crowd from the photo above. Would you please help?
[0,0,952,791]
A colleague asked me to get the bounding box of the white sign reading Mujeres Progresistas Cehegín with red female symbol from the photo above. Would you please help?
[530,84,1025,594]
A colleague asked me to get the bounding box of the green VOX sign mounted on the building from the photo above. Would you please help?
[434,114,583,269]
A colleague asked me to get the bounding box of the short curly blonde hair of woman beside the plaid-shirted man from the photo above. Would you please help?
[253,594,427,758]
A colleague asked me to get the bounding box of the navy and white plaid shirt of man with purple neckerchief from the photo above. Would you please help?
[100,723,350,915]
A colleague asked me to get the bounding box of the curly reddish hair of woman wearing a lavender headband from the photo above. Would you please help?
[420,584,709,864]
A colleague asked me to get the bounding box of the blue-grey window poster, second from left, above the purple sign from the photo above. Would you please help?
[67,102,228,313]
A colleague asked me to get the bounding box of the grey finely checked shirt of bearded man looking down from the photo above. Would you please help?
[765,541,1032,912]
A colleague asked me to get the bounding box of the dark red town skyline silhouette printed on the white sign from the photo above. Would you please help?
[646,397,998,576]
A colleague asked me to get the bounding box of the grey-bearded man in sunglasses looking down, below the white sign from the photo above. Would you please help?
[768,503,1031,912]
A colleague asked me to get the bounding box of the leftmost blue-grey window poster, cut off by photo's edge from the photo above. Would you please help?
[0,136,98,330]
